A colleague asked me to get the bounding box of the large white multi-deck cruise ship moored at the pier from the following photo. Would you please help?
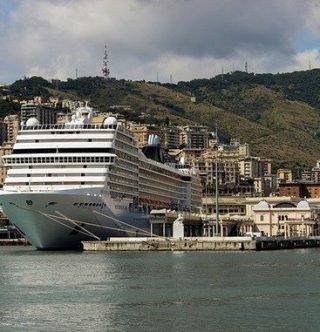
[0,105,201,249]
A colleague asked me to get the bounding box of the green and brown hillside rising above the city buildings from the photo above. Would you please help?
[0,69,320,167]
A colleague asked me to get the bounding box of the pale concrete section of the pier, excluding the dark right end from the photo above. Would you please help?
[82,237,256,251]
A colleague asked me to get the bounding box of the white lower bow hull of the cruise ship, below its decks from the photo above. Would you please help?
[0,191,150,249]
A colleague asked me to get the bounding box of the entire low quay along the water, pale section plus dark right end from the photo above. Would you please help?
[82,236,320,251]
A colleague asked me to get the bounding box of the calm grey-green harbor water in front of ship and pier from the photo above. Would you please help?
[0,246,320,331]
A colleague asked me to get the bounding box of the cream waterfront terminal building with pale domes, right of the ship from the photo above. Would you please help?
[202,196,320,237]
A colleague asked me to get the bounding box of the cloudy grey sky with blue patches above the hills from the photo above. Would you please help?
[0,0,320,84]
